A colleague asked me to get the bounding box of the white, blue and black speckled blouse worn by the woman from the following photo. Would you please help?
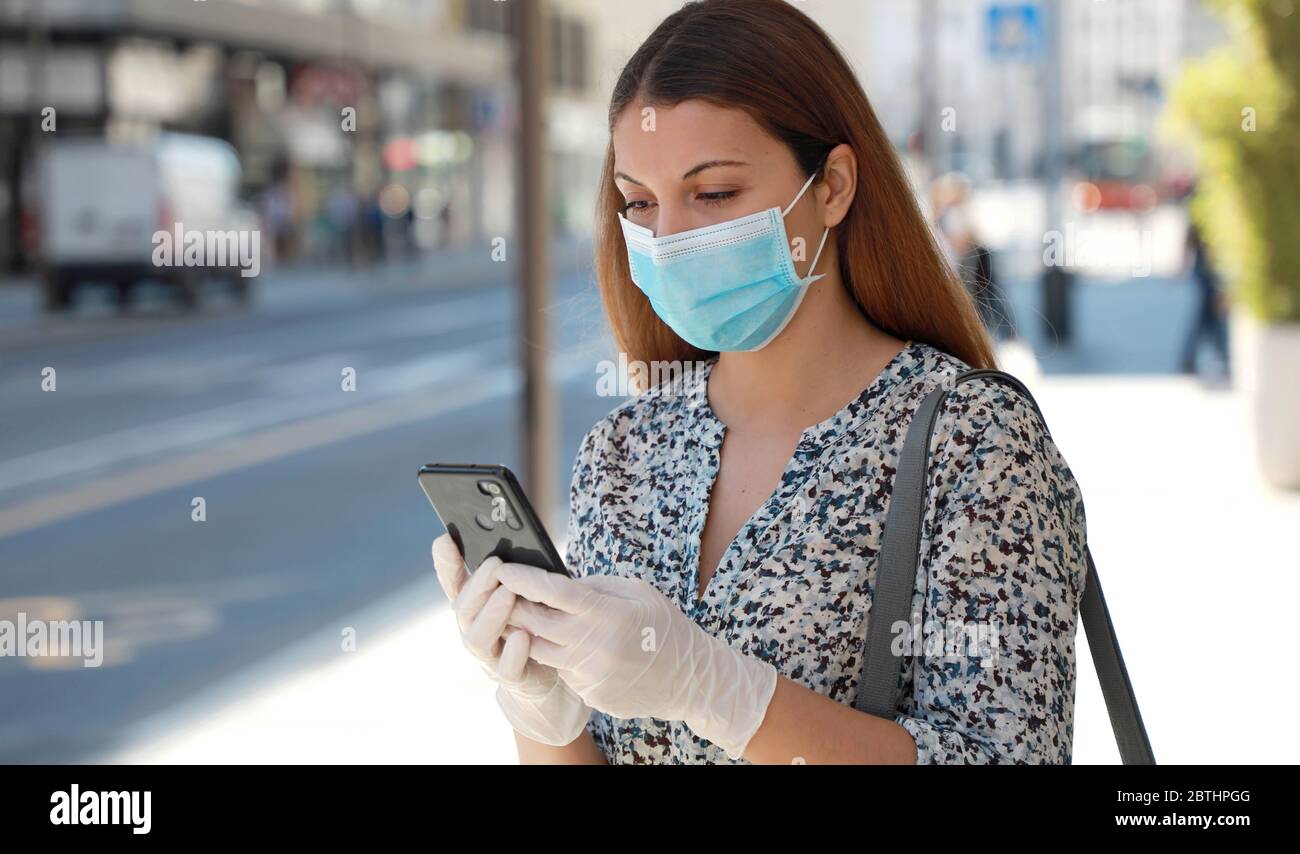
[566,341,1087,764]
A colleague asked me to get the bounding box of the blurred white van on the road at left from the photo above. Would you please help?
[38,134,257,311]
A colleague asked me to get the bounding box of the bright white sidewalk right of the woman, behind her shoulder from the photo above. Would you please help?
[1032,376,1300,764]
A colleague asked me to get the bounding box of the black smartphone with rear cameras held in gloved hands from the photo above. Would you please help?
[417,463,569,576]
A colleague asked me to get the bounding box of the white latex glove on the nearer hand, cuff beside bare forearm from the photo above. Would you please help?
[497,563,776,759]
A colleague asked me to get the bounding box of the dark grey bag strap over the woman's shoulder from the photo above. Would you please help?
[853,368,1156,766]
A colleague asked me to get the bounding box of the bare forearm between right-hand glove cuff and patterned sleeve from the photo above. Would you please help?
[745,676,917,766]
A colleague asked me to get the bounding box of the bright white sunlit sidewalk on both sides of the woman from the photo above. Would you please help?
[104,335,1300,764]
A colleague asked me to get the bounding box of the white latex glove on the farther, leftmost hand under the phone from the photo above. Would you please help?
[433,534,592,746]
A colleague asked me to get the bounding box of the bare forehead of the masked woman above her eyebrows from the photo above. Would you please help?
[612,99,780,178]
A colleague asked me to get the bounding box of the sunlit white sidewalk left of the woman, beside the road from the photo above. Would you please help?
[100,562,517,764]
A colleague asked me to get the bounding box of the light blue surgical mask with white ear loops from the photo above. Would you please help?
[619,165,831,352]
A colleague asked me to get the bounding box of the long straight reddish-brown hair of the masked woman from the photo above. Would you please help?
[595,0,997,368]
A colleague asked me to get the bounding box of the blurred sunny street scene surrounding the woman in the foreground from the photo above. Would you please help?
[0,0,1300,763]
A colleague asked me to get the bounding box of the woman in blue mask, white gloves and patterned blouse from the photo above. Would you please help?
[434,0,1086,763]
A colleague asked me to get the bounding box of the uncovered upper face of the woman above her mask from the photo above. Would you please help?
[614,100,829,246]
